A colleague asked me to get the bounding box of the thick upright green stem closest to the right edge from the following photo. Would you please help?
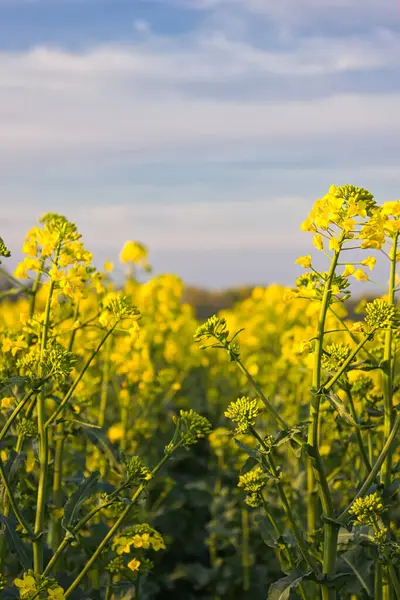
[381,233,399,488]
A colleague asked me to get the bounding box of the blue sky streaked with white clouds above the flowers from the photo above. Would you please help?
[0,0,400,288]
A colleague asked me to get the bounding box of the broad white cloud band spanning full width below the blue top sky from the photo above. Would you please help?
[0,32,400,161]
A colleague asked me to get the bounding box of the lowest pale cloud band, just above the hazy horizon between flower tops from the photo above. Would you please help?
[1,196,309,254]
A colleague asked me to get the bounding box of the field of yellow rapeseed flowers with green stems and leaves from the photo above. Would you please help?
[0,185,400,600]
